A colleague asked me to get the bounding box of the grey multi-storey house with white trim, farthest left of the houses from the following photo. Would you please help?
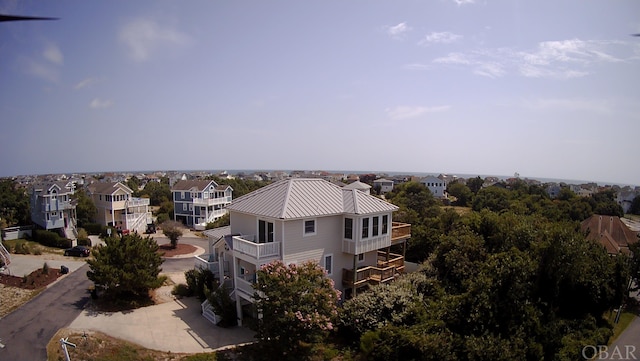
[30,181,78,240]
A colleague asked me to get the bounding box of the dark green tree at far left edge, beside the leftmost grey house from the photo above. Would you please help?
[0,178,31,227]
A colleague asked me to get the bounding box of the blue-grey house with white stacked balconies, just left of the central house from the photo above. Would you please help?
[171,180,233,230]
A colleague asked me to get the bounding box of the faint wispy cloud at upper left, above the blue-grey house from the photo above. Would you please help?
[119,18,191,62]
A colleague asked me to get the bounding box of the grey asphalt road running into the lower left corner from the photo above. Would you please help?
[0,265,92,361]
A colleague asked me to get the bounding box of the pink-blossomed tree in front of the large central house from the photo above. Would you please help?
[254,261,340,360]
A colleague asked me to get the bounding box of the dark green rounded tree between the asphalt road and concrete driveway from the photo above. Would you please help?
[87,233,165,298]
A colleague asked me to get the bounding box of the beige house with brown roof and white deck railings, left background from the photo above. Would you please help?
[87,182,153,233]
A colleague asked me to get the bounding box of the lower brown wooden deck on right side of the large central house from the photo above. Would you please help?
[342,252,404,288]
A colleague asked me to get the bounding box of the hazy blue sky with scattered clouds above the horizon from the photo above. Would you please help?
[0,0,640,184]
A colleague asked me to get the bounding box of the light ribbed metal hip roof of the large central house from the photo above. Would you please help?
[227,178,398,219]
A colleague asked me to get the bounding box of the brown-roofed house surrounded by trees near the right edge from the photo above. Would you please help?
[580,214,638,255]
